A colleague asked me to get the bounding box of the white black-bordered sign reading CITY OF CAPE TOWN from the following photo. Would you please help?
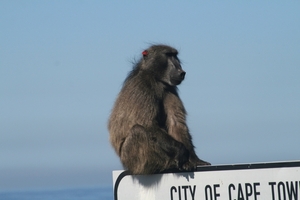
[113,161,300,200]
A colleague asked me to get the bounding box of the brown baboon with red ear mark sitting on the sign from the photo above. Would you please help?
[108,45,210,174]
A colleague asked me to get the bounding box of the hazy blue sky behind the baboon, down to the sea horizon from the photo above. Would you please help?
[0,0,300,190]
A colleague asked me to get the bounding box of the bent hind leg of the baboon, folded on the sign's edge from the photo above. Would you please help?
[121,125,189,174]
